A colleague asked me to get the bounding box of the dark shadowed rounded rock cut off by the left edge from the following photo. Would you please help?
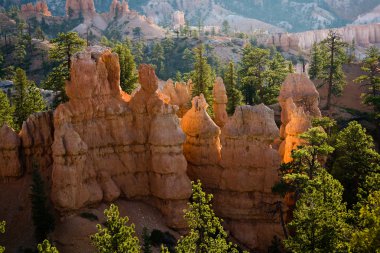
[0,125,22,180]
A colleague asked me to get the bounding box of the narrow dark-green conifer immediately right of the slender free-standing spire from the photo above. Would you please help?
[224,61,243,115]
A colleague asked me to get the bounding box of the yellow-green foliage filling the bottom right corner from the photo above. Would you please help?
[351,191,380,253]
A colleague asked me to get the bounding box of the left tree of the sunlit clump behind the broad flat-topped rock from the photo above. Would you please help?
[239,45,270,105]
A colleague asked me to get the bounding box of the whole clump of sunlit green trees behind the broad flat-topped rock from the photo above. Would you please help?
[239,45,292,105]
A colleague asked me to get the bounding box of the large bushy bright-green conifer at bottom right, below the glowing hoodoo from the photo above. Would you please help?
[284,170,350,253]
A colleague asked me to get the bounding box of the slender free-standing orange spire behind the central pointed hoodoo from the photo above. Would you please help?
[213,77,228,128]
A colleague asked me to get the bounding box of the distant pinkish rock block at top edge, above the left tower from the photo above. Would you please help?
[66,0,96,18]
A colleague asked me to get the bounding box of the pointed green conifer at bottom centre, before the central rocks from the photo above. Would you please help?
[176,181,238,253]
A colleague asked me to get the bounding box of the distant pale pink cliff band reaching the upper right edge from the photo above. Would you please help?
[262,23,380,52]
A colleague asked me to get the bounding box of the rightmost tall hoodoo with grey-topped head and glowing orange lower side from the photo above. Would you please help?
[278,74,321,163]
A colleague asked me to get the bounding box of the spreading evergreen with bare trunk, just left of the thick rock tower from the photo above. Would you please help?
[49,32,86,79]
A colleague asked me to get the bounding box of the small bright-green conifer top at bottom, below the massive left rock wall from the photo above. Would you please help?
[90,204,141,253]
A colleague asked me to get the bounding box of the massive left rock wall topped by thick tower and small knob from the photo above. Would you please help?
[52,47,191,227]
